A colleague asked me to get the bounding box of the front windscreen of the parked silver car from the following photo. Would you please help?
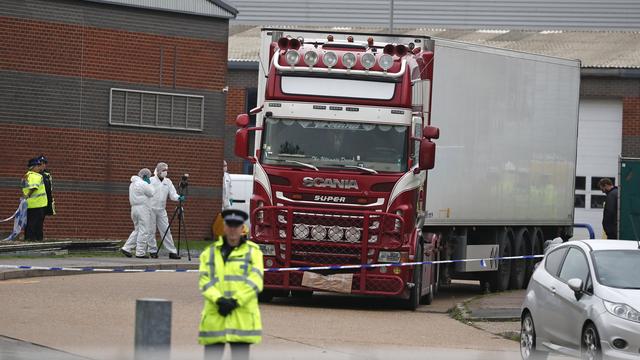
[592,250,640,289]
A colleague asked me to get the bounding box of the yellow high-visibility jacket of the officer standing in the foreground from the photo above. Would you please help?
[198,237,264,345]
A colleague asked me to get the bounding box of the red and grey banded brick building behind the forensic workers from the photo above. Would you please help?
[0,0,237,239]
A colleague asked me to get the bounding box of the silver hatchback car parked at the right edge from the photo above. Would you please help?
[520,240,640,360]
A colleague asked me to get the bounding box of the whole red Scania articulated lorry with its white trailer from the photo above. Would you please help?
[235,29,580,309]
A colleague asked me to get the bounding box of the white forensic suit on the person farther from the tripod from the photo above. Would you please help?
[122,175,158,256]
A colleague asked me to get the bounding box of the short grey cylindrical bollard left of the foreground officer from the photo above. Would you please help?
[134,299,171,360]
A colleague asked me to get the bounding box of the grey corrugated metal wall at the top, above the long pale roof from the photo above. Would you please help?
[227,0,640,30]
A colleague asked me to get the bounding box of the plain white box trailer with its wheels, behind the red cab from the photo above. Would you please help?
[424,39,580,290]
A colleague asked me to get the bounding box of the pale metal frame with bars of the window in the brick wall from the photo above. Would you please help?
[109,88,204,132]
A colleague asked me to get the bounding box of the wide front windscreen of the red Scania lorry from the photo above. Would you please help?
[262,118,409,172]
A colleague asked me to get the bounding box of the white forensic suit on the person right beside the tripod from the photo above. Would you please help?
[151,175,180,254]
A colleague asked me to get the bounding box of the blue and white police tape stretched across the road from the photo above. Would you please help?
[0,255,544,273]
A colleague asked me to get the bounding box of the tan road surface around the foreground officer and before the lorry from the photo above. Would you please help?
[0,273,519,360]
